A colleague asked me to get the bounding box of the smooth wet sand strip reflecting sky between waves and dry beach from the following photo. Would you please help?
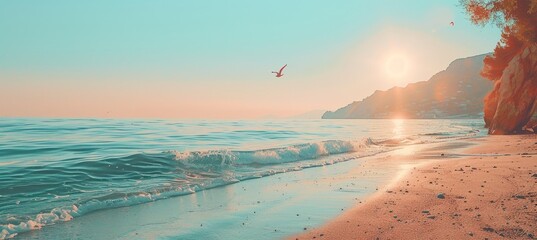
[17,137,524,239]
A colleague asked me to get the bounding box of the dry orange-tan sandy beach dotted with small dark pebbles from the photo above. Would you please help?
[290,135,537,239]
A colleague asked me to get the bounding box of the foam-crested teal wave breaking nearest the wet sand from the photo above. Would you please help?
[0,138,383,239]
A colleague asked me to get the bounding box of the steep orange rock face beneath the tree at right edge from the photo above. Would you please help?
[484,44,537,134]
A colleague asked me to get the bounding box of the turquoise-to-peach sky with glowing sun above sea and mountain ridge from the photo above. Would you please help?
[0,0,500,119]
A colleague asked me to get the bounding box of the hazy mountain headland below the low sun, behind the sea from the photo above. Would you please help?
[322,54,493,119]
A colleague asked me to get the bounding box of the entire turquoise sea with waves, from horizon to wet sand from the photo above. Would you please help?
[0,118,484,239]
